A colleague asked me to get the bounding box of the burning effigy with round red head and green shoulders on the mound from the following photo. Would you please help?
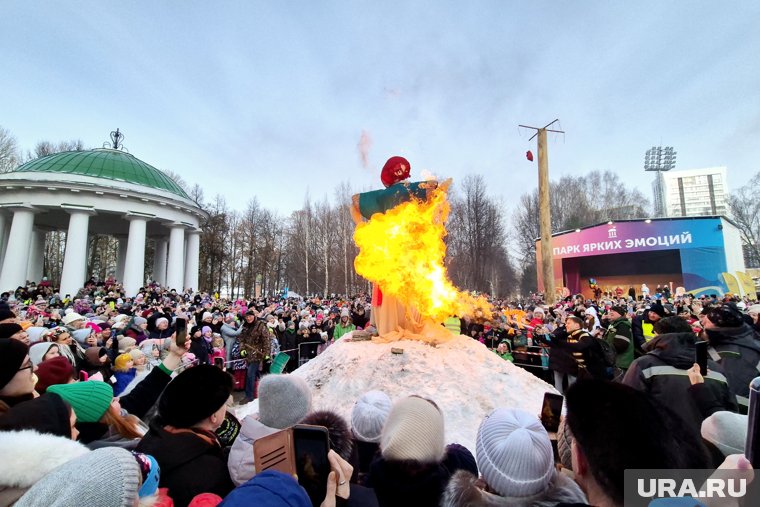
[352,157,488,343]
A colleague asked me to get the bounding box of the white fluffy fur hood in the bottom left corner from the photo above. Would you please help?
[0,430,90,488]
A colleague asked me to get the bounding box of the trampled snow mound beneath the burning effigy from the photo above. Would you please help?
[236,335,556,453]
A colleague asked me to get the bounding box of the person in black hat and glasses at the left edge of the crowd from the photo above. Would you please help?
[0,338,37,414]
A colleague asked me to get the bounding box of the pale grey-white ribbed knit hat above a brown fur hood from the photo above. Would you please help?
[475,408,554,498]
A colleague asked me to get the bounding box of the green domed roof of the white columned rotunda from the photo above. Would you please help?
[13,149,189,199]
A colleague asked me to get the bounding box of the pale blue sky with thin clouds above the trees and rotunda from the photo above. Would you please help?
[0,0,760,215]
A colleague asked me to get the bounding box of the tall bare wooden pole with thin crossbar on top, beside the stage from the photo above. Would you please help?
[520,119,565,305]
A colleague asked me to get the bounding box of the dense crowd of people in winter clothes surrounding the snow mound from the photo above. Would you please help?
[0,280,760,507]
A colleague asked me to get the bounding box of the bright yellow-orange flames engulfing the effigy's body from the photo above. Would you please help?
[354,180,488,323]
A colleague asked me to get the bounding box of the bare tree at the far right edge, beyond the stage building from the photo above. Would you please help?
[728,172,760,268]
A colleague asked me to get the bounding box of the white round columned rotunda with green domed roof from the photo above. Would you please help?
[0,142,207,296]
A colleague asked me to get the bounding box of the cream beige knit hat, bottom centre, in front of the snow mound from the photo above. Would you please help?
[380,396,446,463]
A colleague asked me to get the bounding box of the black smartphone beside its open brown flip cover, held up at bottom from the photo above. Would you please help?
[293,424,330,505]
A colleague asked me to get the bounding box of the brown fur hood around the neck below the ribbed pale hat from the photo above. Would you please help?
[441,470,587,507]
